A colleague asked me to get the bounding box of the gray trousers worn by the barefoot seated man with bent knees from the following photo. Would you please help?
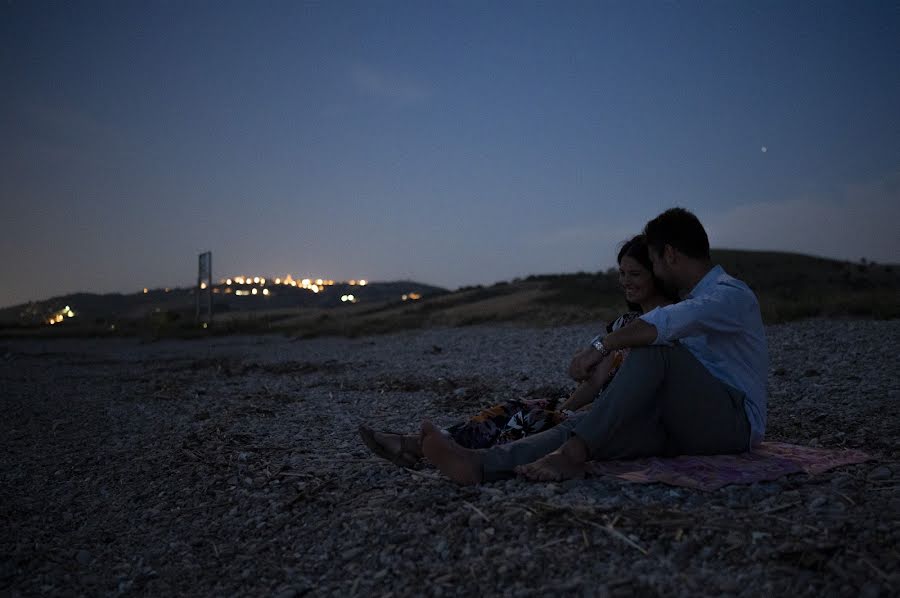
[482,344,750,481]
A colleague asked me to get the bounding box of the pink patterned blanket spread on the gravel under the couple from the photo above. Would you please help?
[588,442,872,491]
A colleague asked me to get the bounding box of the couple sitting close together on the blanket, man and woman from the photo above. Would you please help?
[359,208,769,484]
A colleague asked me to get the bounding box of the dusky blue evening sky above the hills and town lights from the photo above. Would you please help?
[0,0,900,306]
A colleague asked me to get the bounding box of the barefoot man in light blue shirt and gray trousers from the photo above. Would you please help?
[422,208,769,484]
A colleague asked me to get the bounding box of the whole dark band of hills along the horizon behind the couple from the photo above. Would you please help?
[0,249,900,337]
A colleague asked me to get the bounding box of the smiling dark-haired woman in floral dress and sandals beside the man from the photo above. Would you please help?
[359,235,673,467]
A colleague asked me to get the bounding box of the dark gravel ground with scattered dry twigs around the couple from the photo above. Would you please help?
[0,320,900,597]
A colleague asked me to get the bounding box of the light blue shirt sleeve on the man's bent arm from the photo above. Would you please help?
[641,285,755,345]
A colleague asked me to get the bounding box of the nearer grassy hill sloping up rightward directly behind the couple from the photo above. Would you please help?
[285,249,900,336]
